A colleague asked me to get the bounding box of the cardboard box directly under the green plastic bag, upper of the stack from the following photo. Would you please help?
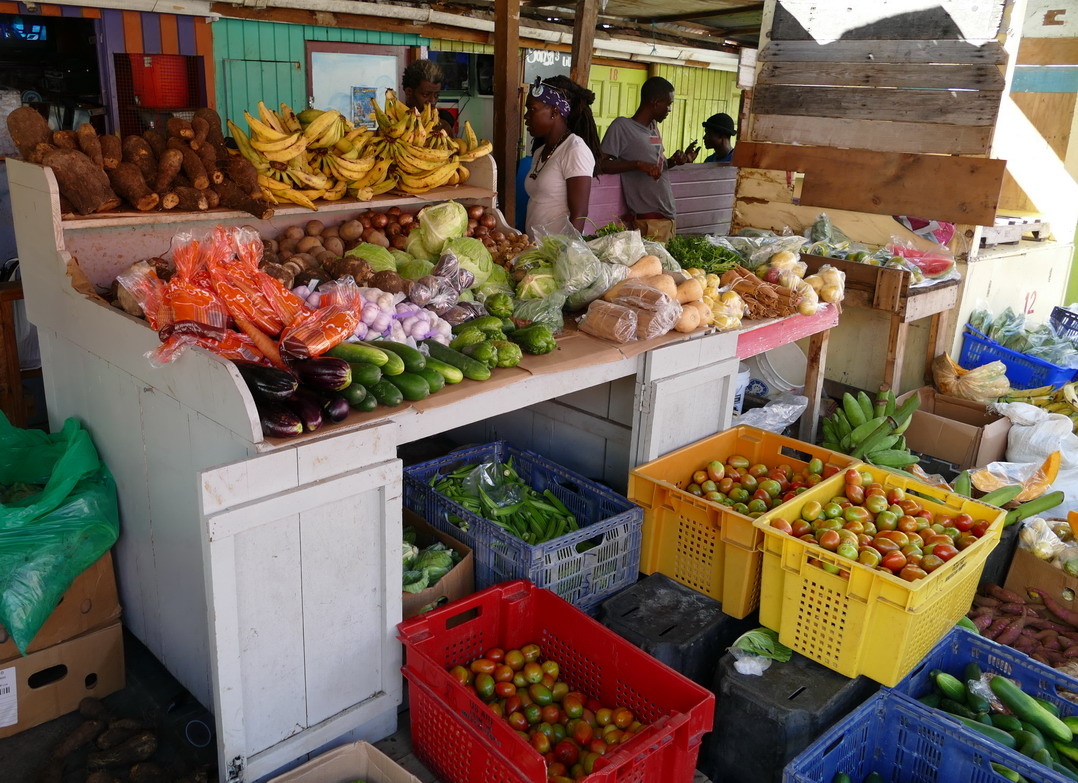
[0,552,120,661]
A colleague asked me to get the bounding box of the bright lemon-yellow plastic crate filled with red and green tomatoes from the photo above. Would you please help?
[754,465,1005,687]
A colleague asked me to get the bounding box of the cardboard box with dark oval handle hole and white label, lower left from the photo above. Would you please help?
[0,622,124,739]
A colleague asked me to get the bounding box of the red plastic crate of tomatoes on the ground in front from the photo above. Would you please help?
[399,580,715,783]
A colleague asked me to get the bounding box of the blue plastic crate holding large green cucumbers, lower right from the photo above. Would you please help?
[894,628,1078,715]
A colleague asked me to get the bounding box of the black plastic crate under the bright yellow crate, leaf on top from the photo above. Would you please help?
[696,654,879,783]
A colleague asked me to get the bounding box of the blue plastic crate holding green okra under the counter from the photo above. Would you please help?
[404,441,644,614]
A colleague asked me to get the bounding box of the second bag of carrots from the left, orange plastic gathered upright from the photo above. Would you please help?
[158,234,229,340]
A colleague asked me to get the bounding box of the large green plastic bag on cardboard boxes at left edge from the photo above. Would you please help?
[0,413,120,655]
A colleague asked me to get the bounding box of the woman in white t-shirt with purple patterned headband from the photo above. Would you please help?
[524,77,599,238]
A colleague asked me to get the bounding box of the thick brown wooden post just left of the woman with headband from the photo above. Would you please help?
[494,0,521,223]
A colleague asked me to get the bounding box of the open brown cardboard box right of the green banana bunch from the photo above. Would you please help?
[898,386,1011,469]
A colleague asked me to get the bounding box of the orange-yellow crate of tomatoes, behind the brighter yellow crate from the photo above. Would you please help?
[628,427,857,618]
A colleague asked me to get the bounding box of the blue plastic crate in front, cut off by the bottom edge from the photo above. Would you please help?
[783,690,1062,783]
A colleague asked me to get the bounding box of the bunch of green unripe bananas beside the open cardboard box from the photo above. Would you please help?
[823,388,921,468]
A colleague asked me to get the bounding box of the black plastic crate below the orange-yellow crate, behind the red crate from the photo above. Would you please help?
[598,574,759,688]
